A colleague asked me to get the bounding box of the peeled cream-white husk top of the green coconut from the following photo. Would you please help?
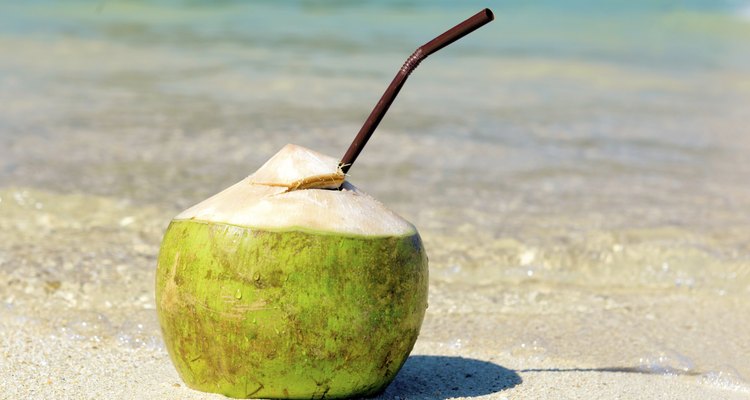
[175,144,416,236]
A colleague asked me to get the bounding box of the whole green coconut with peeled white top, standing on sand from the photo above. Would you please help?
[156,145,428,398]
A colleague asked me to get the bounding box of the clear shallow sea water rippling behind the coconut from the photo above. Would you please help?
[0,1,750,395]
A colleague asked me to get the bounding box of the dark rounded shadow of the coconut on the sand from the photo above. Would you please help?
[375,356,521,400]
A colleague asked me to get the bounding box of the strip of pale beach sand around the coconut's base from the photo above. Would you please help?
[0,296,750,399]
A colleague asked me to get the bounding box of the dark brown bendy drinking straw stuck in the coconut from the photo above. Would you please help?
[339,8,495,173]
